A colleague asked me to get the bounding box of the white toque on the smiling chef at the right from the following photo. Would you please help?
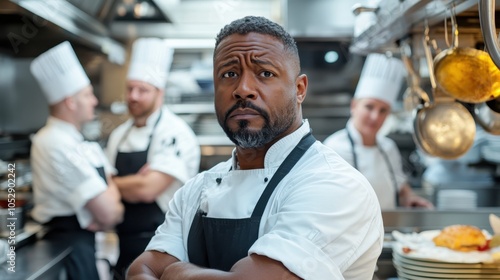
[354,53,406,106]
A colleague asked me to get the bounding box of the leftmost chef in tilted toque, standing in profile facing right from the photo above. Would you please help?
[31,42,123,280]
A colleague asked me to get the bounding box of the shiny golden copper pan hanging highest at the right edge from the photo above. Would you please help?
[434,9,500,103]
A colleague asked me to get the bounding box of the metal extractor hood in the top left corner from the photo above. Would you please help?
[0,0,126,64]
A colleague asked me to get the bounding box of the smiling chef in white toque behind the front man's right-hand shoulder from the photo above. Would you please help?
[324,53,433,209]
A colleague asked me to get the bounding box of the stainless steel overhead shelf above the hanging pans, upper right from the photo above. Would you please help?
[349,0,478,54]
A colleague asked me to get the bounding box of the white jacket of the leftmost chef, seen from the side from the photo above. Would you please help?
[30,117,113,228]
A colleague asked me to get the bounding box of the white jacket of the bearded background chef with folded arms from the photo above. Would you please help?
[106,106,200,211]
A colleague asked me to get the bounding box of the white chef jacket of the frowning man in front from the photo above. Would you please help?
[146,121,384,280]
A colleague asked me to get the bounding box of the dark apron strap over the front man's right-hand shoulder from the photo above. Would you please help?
[252,132,316,217]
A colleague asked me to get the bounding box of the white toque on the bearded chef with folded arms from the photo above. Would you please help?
[127,38,174,89]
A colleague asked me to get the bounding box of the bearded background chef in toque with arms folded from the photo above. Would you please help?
[107,38,200,279]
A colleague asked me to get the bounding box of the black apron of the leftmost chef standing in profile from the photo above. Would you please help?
[43,167,107,280]
